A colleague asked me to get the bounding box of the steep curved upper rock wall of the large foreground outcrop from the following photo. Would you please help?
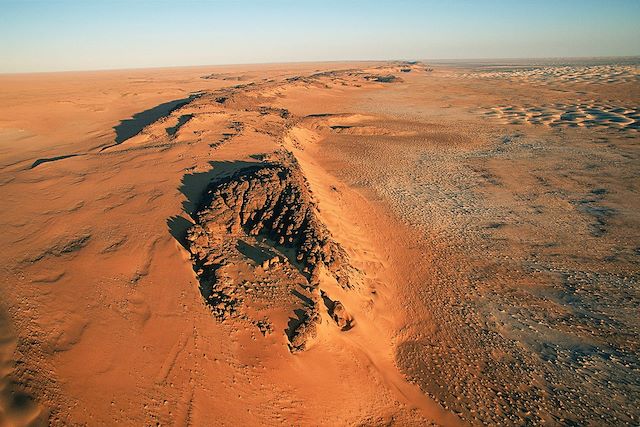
[188,159,351,288]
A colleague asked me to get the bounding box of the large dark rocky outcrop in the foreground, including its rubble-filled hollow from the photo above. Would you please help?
[187,156,355,352]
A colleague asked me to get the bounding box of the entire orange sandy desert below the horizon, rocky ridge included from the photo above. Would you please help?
[0,58,640,426]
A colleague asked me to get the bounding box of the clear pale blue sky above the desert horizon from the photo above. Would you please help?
[0,0,640,73]
